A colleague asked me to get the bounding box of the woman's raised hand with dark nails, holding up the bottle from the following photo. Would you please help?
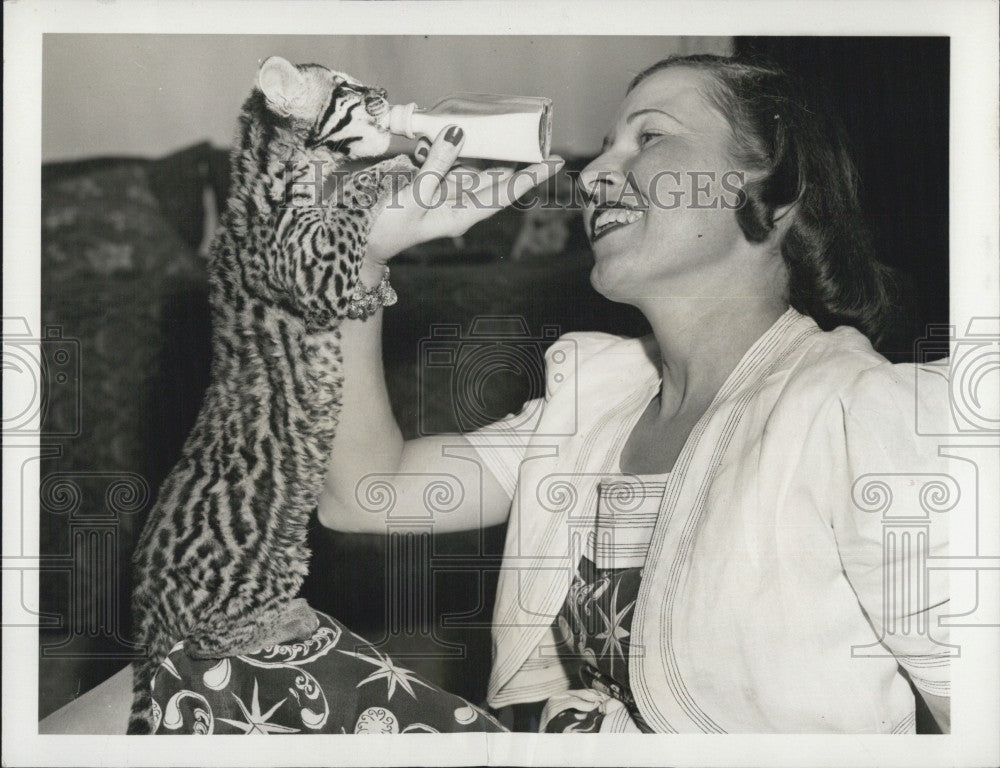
[362,126,563,285]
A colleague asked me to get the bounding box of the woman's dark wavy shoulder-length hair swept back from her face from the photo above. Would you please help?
[629,54,895,343]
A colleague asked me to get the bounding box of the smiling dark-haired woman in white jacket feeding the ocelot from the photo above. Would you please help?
[319,56,948,733]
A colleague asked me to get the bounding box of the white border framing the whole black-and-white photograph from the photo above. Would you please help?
[3,0,1000,768]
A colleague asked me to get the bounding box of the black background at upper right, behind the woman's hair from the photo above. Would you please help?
[736,37,950,362]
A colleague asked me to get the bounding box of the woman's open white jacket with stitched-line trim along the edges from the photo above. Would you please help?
[467,309,958,733]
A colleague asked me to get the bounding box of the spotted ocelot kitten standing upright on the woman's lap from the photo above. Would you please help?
[128,57,412,733]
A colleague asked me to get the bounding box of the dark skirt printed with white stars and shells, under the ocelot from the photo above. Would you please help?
[153,611,506,734]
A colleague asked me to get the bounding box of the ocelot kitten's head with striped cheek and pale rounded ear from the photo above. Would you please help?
[257,56,390,157]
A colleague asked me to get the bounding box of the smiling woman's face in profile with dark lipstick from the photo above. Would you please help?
[580,67,746,304]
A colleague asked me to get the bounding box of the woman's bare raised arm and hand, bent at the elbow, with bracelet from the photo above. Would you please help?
[319,128,561,533]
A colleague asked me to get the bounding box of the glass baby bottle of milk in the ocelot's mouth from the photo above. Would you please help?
[389,93,552,163]
